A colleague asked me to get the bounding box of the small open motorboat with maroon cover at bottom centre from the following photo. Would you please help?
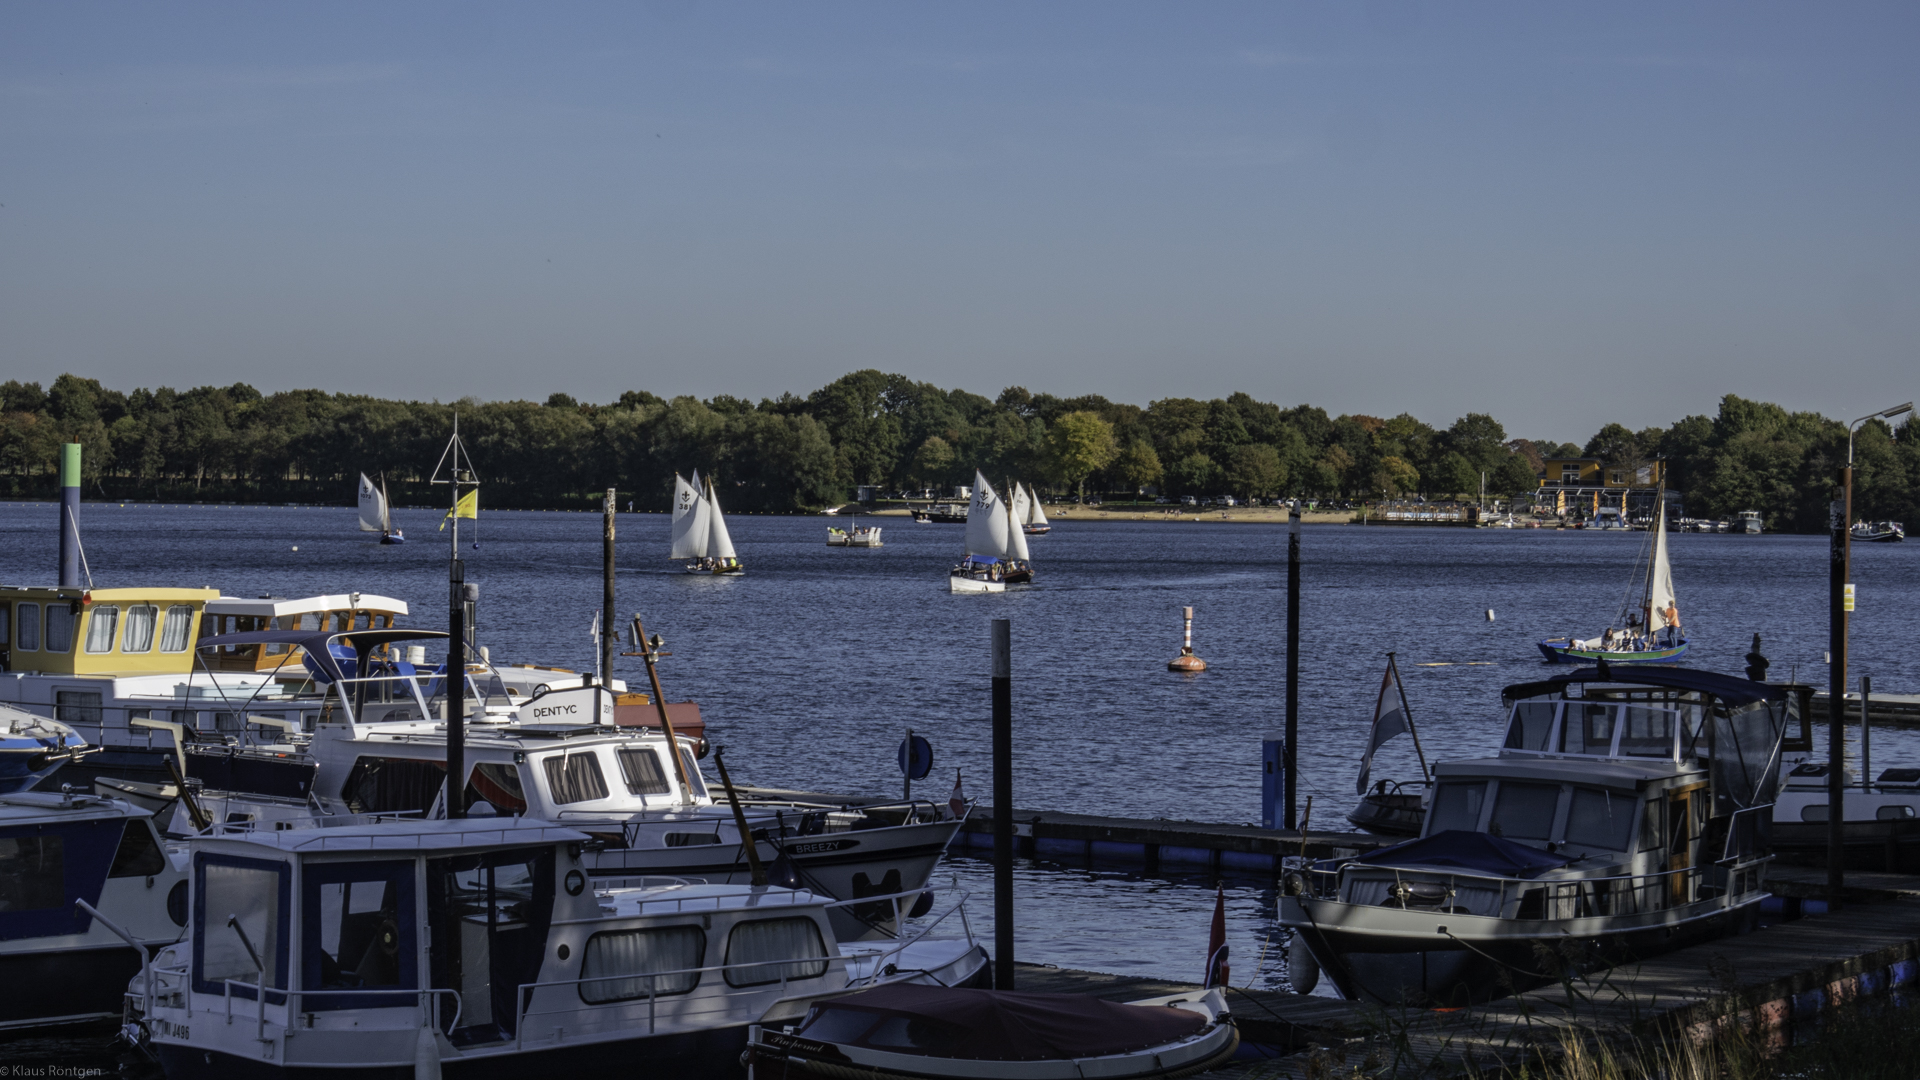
[747,984,1240,1080]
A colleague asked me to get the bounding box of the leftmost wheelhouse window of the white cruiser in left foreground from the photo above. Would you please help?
[194,855,290,999]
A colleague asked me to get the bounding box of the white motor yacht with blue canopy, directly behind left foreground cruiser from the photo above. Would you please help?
[175,630,964,940]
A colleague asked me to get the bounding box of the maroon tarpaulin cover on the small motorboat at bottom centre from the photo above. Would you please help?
[797,984,1206,1061]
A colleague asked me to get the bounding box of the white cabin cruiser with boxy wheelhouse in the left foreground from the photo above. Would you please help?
[121,819,987,1080]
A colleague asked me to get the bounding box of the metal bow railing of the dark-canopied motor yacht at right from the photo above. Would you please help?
[1284,855,1770,919]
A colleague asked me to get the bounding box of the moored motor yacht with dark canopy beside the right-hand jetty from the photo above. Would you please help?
[1281,665,1793,1007]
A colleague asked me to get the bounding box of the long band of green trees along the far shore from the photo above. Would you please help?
[0,371,1920,530]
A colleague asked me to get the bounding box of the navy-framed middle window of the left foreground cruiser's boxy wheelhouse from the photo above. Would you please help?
[300,859,419,1013]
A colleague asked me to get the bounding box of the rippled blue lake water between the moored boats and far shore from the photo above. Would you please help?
[0,503,1920,1053]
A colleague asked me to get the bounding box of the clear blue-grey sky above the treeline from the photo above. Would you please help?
[0,0,1920,442]
